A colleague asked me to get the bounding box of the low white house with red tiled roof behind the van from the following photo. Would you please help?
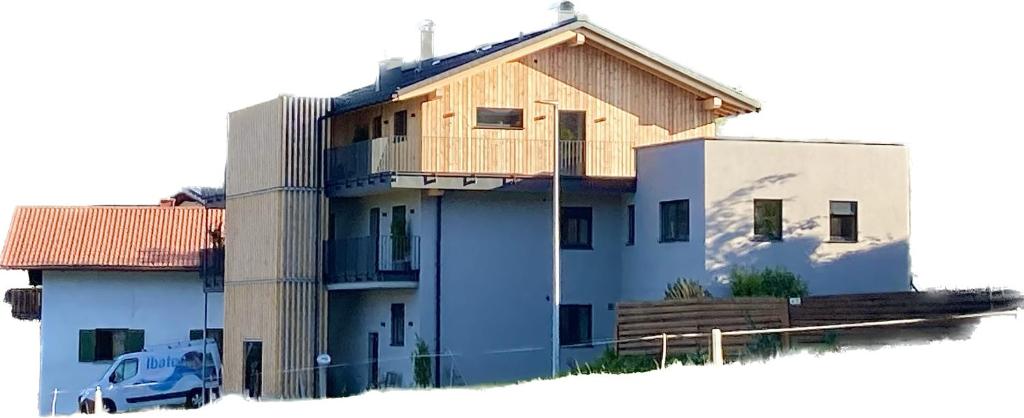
[0,199,223,415]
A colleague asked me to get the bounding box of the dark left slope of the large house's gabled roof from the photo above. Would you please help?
[329,18,577,116]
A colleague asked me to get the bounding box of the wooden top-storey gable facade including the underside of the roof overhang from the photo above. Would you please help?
[331,23,751,177]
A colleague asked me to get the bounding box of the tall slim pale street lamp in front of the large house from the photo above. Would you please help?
[537,100,562,377]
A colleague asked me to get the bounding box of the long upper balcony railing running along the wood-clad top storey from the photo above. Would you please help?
[326,136,634,186]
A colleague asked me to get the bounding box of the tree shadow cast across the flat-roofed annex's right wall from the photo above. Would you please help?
[705,173,910,296]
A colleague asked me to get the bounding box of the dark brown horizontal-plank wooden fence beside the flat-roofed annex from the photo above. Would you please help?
[615,290,1022,358]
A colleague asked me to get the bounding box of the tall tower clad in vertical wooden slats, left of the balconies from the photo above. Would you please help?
[224,96,330,398]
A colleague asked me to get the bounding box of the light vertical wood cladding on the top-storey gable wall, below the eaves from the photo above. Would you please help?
[332,44,716,177]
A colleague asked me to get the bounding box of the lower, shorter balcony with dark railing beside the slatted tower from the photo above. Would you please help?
[324,236,420,289]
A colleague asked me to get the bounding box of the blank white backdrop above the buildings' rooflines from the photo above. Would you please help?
[0,0,1024,413]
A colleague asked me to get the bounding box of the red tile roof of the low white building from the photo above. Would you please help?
[0,206,223,270]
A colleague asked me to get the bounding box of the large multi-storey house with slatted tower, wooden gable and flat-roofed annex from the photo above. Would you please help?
[224,5,910,398]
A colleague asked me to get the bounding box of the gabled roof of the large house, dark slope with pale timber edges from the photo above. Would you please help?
[329,18,761,116]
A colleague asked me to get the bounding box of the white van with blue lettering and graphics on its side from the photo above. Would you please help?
[78,338,222,413]
